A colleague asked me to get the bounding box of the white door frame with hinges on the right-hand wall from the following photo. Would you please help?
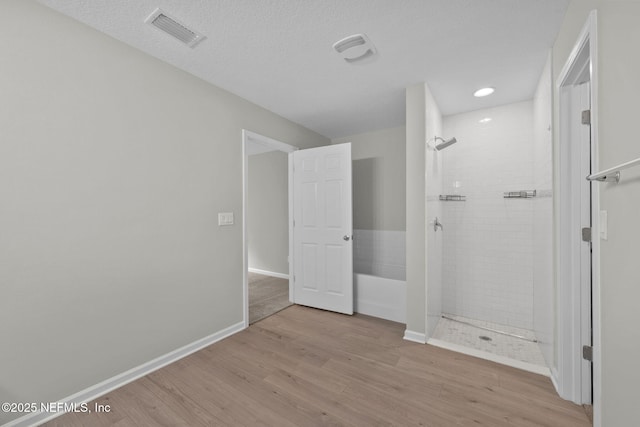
[552,10,601,426]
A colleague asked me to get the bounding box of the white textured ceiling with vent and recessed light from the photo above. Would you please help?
[40,0,568,137]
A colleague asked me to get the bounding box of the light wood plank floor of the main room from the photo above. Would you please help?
[47,306,590,427]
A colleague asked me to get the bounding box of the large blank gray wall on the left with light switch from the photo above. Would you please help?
[0,0,329,424]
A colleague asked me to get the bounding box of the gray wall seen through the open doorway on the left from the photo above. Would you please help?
[247,151,289,275]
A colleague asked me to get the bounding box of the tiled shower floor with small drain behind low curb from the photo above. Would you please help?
[431,314,546,368]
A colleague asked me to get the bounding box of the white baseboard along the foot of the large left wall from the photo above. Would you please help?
[2,322,245,427]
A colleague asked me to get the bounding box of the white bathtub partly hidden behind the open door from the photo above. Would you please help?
[353,273,407,323]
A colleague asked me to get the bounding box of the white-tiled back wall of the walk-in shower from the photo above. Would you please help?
[438,101,535,329]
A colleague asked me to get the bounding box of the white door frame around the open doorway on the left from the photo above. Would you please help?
[242,129,298,328]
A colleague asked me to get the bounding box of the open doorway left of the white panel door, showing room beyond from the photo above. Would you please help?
[242,130,297,327]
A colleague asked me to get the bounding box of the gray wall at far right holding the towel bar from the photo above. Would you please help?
[553,0,640,427]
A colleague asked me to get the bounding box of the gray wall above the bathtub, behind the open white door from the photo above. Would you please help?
[331,126,406,231]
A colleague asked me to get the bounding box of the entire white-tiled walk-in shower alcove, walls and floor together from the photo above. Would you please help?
[426,90,553,374]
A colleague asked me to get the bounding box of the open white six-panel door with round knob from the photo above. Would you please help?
[292,143,353,314]
